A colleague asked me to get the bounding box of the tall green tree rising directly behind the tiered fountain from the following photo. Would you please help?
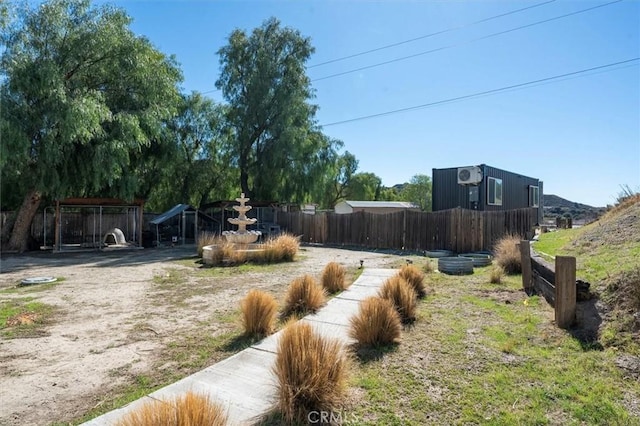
[216,18,324,201]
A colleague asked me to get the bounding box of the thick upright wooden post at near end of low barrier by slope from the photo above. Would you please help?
[555,256,576,328]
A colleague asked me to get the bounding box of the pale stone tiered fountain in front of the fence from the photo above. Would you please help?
[202,192,263,265]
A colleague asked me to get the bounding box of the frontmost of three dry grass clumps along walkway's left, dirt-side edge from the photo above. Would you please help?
[240,289,278,336]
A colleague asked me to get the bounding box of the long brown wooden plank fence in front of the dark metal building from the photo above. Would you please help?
[277,208,537,253]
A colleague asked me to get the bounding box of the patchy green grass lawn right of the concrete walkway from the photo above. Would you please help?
[352,268,640,425]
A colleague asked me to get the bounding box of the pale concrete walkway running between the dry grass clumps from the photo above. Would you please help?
[84,269,397,426]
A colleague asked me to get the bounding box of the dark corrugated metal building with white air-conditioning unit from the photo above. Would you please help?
[432,164,543,223]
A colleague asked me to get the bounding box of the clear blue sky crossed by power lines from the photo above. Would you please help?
[96,0,640,206]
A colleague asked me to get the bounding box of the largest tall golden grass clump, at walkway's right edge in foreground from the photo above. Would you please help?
[274,322,348,424]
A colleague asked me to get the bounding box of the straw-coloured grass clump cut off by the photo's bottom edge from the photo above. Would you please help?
[116,392,227,426]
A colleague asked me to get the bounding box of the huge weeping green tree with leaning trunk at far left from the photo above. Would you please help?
[0,0,181,251]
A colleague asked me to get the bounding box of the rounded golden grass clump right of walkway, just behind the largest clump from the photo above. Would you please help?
[349,297,402,347]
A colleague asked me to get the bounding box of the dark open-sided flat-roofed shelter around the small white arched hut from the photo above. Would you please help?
[54,198,144,251]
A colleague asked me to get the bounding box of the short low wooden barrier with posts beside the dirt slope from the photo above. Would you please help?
[520,241,577,328]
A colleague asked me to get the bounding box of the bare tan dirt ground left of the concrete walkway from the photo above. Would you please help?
[0,247,402,426]
